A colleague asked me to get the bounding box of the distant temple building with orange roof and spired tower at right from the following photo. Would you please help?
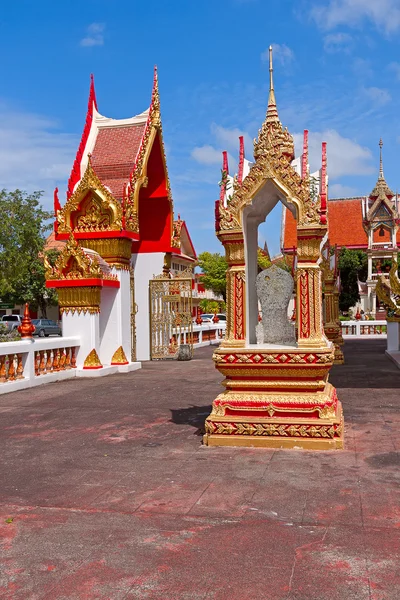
[281,140,400,319]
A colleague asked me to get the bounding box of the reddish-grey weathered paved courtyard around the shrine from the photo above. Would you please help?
[0,340,400,600]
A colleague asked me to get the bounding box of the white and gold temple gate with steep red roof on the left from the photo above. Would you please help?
[46,69,196,369]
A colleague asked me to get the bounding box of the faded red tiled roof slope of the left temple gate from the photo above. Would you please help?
[92,123,146,198]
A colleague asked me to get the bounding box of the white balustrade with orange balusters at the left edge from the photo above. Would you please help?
[0,337,80,394]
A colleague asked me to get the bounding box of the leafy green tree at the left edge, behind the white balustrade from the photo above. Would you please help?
[0,190,56,316]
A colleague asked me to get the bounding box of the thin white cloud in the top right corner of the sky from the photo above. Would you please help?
[311,0,400,34]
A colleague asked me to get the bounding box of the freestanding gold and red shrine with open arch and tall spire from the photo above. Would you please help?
[204,48,343,450]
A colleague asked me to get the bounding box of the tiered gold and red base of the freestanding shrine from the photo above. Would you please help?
[203,344,343,450]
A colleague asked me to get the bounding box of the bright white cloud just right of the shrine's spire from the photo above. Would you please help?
[294,129,375,181]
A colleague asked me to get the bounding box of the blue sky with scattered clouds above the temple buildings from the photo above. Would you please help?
[0,0,400,253]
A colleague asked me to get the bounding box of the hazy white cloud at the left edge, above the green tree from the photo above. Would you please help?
[0,103,78,208]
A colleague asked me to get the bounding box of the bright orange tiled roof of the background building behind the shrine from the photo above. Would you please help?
[283,198,368,251]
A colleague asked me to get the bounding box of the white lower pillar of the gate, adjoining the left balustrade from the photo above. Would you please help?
[62,312,100,369]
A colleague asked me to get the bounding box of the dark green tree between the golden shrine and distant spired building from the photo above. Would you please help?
[338,248,368,311]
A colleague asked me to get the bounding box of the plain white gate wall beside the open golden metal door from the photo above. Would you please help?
[132,252,165,361]
